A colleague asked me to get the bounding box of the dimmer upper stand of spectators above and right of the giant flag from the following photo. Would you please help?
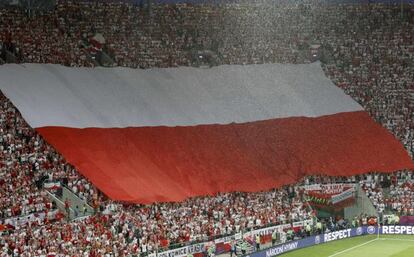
[0,1,414,156]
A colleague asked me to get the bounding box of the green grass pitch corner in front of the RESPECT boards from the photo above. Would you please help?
[281,235,414,257]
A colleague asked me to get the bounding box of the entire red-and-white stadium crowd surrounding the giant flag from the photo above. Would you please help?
[0,0,414,256]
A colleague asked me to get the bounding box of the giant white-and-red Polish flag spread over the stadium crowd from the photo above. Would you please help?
[0,63,413,203]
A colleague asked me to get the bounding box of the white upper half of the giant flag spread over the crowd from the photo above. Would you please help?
[0,63,362,128]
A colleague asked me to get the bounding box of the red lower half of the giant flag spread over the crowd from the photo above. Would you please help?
[38,112,413,203]
